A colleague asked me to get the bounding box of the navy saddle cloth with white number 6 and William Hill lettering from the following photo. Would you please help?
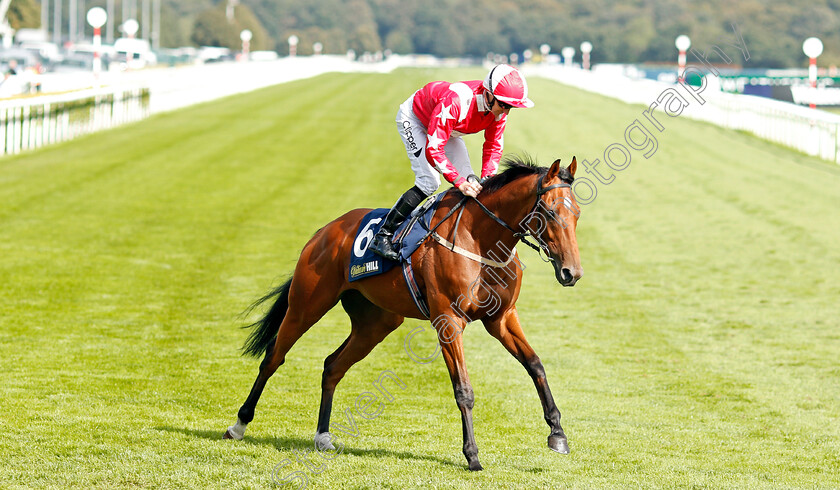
[350,192,446,282]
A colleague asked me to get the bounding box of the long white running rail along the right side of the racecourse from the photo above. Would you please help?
[527,65,840,163]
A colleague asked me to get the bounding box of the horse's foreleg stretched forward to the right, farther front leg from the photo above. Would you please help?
[484,307,570,454]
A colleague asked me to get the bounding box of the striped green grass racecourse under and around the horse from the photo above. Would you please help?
[0,69,840,489]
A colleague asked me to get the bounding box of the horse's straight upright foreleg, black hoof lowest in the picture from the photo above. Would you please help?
[438,315,483,471]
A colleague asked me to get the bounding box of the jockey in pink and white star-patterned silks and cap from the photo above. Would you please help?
[370,65,534,261]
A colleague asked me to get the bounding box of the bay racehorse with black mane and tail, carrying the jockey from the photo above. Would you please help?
[223,157,583,471]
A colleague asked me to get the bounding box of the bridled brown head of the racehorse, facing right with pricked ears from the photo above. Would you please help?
[528,157,583,286]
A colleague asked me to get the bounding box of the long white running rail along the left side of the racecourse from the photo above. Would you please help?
[0,56,411,156]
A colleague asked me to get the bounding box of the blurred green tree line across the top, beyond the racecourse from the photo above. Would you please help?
[10,0,840,68]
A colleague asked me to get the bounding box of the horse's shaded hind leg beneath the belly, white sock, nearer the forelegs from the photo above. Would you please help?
[316,290,403,449]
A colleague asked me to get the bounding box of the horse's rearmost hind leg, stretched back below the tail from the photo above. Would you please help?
[224,272,338,439]
